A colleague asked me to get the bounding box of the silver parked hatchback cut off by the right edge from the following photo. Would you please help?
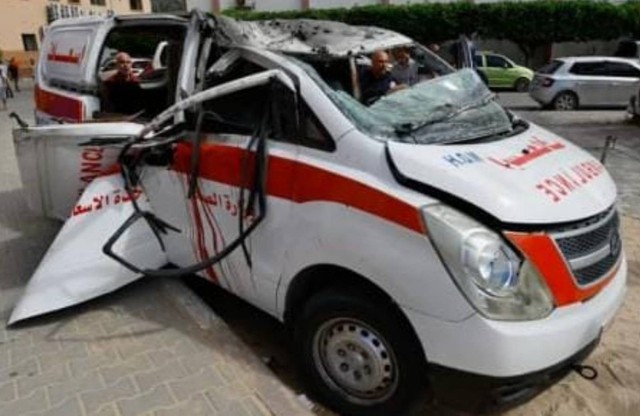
[529,56,640,110]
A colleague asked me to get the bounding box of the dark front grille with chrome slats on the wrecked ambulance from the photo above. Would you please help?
[554,209,622,286]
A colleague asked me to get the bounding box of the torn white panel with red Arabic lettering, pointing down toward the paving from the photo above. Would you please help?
[9,173,167,324]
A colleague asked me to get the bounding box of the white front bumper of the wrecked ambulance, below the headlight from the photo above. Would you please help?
[405,257,627,378]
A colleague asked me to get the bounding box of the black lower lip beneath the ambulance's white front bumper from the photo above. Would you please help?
[429,337,600,412]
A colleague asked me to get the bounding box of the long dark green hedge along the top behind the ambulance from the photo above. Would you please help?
[228,0,640,65]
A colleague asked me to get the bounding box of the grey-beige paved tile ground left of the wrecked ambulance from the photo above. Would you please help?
[0,82,307,416]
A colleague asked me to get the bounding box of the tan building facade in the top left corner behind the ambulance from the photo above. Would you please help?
[0,0,151,75]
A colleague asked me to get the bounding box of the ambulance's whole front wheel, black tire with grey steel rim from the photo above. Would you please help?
[294,288,426,416]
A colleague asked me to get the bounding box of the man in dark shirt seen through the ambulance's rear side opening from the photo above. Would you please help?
[102,52,143,114]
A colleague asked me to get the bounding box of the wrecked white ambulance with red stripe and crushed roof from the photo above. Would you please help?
[11,10,627,415]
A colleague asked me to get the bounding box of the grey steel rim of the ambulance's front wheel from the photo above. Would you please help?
[313,318,399,405]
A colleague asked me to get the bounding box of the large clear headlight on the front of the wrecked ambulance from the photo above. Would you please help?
[423,204,553,320]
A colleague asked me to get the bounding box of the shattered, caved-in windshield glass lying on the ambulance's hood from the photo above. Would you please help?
[296,56,512,144]
